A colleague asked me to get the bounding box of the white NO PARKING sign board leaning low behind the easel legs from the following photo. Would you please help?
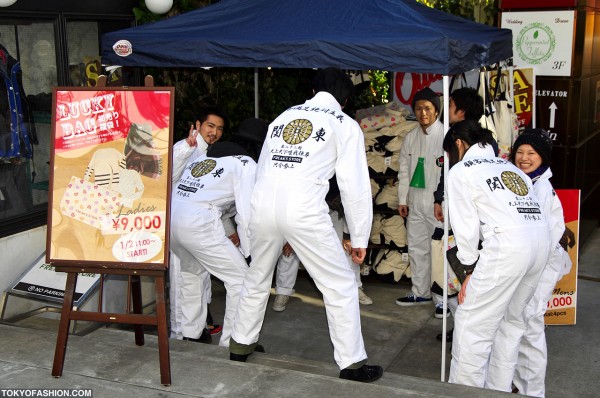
[11,253,100,305]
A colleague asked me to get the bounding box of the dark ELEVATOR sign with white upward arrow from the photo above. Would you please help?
[536,79,570,146]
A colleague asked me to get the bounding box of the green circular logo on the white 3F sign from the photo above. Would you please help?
[516,22,556,65]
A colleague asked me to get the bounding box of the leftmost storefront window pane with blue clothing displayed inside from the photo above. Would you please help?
[0,20,57,222]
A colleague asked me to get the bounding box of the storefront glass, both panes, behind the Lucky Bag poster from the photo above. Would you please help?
[0,14,135,238]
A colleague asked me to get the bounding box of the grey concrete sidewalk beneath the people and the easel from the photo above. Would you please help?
[0,230,600,398]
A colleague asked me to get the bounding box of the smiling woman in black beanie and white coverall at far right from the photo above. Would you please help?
[488,129,571,397]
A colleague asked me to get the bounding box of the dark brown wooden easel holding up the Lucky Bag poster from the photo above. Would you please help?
[52,76,171,386]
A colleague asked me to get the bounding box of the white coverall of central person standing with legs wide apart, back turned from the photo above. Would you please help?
[232,92,373,369]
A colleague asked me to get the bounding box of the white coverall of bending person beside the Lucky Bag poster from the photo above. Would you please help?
[171,156,256,347]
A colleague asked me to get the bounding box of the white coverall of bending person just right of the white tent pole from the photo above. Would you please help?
[447,144,549,387]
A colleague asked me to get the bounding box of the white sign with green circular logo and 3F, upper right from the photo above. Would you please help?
[501,10,575,76]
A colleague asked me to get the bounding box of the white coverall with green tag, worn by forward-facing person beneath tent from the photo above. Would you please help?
[398,120,444,298]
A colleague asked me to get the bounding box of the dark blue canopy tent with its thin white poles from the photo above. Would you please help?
[101,0,512,381]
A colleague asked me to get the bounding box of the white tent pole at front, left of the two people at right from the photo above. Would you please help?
[440,75,450,382]
